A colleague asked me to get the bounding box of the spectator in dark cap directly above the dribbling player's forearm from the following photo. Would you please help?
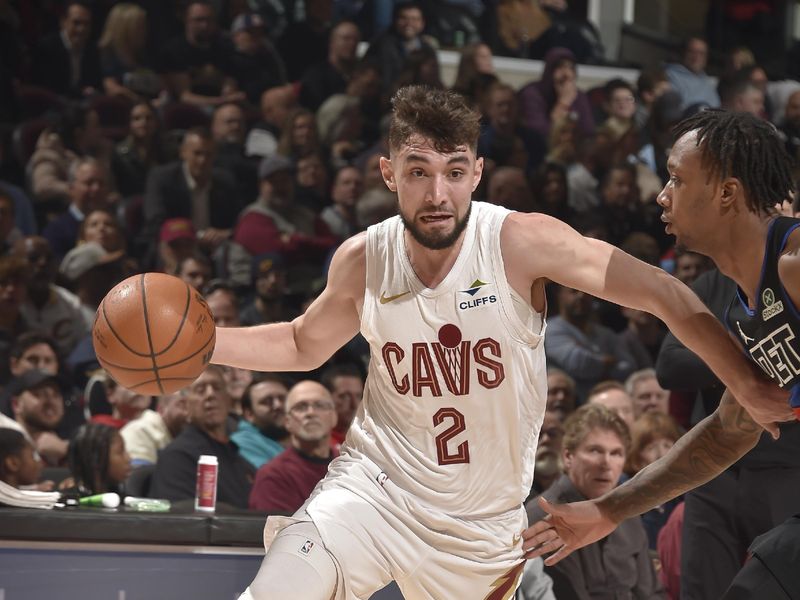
[240,254,297,326]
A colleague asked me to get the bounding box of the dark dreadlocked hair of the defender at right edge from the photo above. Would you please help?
[674,109,795,214]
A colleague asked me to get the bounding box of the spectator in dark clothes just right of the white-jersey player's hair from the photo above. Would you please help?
[478,83,546,174]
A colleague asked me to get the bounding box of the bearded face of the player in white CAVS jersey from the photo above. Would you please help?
[380,137,483,250]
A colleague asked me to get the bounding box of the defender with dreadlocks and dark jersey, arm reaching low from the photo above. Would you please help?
[523,110,800,600]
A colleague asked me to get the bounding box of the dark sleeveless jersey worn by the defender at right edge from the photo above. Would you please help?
[725,217,800,415]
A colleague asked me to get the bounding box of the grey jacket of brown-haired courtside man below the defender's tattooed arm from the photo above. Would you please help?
[525,475,666,600]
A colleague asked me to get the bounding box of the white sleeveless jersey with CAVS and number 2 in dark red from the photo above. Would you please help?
[344,202,547,518]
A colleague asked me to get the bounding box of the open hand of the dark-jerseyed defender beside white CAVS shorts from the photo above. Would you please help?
[522,497,617,567]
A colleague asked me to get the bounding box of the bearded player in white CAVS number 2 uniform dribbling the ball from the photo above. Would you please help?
[212,87,785,600]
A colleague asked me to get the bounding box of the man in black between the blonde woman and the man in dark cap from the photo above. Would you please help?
[159,0,246,109]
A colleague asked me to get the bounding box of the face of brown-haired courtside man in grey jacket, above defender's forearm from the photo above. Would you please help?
[564,429,625,500]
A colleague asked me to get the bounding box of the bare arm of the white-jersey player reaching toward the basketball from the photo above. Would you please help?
[211,234,367,371]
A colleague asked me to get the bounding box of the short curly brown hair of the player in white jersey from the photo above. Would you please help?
[389,85,481,153]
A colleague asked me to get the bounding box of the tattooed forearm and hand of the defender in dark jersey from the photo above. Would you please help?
[523,391,763,565]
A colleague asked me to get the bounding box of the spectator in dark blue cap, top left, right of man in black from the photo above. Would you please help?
[231,13,287,106]
